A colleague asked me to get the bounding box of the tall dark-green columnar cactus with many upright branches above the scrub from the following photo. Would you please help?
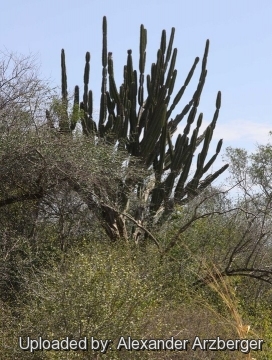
[51,17,228,242]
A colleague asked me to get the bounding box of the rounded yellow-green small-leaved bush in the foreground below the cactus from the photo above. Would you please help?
[0,234,269,360]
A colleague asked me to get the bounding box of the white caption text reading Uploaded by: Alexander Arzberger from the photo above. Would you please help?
[19,336,264,354]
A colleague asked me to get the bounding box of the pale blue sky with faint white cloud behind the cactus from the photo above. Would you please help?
[0,0,272,187]
